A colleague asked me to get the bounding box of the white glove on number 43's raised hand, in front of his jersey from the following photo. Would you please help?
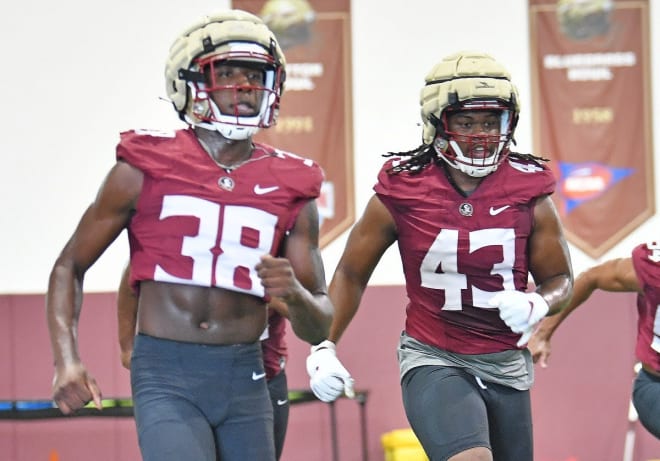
[488,290,550,347]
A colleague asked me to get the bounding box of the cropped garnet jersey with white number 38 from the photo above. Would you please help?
[117,129,323,296]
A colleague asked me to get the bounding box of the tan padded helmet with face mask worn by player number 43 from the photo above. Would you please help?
[421,51,520,177]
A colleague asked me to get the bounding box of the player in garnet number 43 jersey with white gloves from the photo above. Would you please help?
[307,51,572,461]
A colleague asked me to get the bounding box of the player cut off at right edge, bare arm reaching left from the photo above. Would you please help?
[528,241,660,439]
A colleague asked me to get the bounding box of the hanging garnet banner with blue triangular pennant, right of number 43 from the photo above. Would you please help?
[529,0,655,258]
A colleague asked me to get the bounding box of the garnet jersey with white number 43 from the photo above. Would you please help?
[374,158,555,354]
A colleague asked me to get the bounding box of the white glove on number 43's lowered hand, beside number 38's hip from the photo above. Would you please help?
[307,340,355,402]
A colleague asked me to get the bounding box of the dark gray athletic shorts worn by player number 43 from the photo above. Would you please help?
[401,365,534,461]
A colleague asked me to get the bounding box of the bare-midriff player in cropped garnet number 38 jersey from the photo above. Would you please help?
[46,10,333,461]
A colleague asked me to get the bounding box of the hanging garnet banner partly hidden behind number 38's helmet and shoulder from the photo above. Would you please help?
[232,0,355,247]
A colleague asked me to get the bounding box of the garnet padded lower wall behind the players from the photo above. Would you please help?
[0,286,660,461]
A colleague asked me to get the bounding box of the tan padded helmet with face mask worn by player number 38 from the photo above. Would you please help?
[165,10,286,140]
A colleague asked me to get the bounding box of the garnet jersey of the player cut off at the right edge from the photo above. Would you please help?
[632,242,660,372]
